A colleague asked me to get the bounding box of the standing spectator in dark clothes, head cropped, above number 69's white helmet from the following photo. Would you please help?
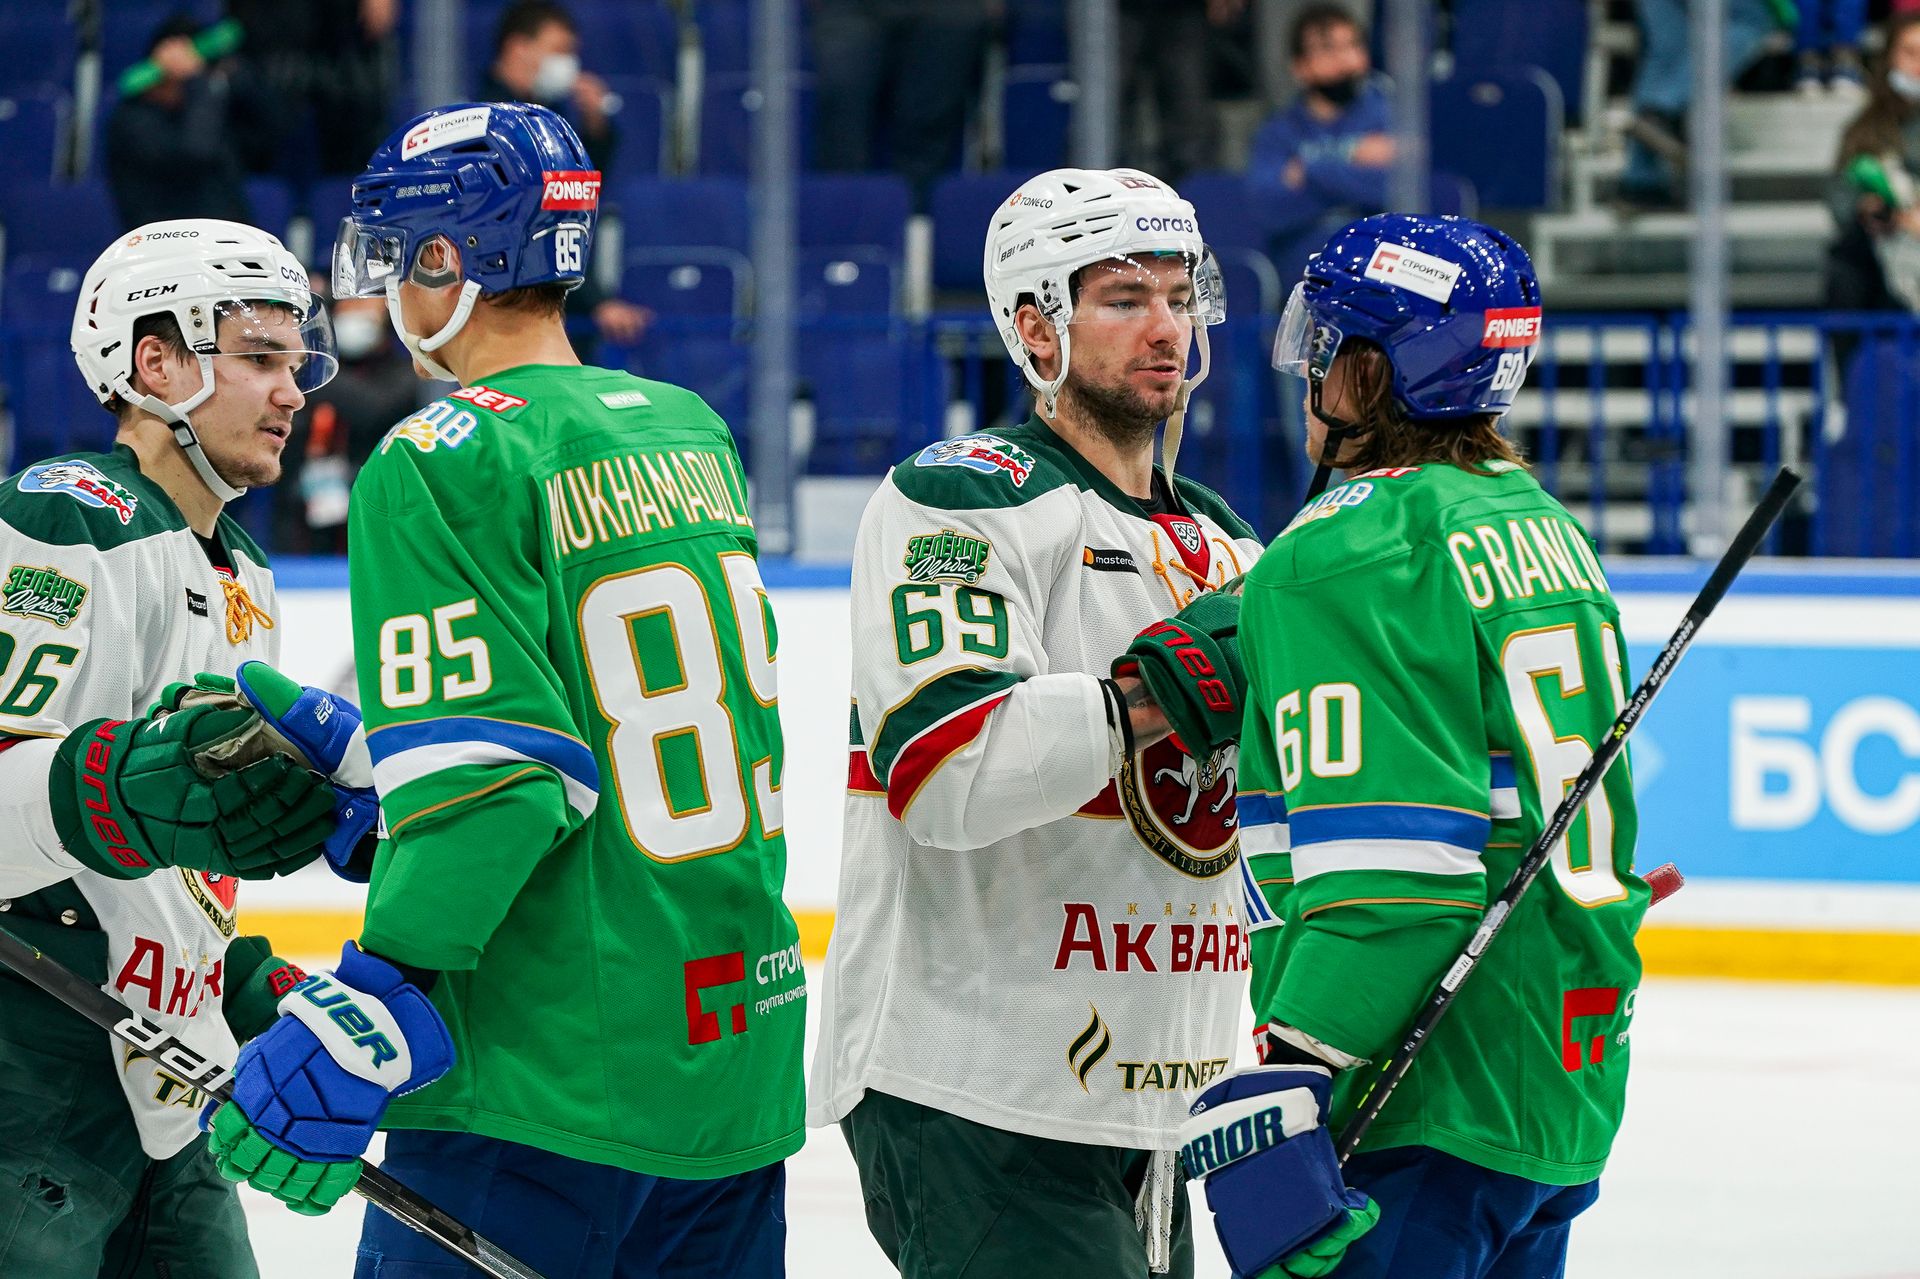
[1121,0,1246,186]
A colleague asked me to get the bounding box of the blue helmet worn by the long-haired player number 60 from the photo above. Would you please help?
[1273,213,1540,421]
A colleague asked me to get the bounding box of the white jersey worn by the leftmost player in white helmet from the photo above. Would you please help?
[0,447,278,1158]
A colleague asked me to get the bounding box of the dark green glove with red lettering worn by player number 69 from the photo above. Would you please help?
[1114,591,1246,759]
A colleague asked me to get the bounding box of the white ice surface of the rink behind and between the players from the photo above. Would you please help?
[242,979,1920,1279]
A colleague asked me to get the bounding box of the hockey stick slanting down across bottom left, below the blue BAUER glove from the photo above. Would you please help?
[0,928,541,1279]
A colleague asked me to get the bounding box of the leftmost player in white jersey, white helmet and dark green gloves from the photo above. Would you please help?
[0,219,357,1279]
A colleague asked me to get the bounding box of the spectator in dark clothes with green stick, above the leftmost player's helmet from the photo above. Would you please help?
[106,17,252,227]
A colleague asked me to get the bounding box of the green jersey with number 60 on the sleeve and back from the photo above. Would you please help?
[1240,463,1647,1185]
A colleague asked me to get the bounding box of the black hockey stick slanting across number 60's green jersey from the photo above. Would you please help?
[1340,467,1801,1164]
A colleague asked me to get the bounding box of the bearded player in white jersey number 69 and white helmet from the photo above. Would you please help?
[808,169,1260,1277]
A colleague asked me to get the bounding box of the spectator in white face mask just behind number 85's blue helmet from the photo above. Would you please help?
[480,0,653,365]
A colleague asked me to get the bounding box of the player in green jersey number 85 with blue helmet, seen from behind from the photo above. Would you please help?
[213,104,804,1279]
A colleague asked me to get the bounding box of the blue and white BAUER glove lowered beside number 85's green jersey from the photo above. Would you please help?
[202,941,453,1210]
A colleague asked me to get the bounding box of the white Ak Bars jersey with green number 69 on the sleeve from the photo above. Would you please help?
[808,419,1260,1150]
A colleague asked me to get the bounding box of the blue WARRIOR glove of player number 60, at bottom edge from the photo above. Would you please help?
[1181,1066,1380,1279]
